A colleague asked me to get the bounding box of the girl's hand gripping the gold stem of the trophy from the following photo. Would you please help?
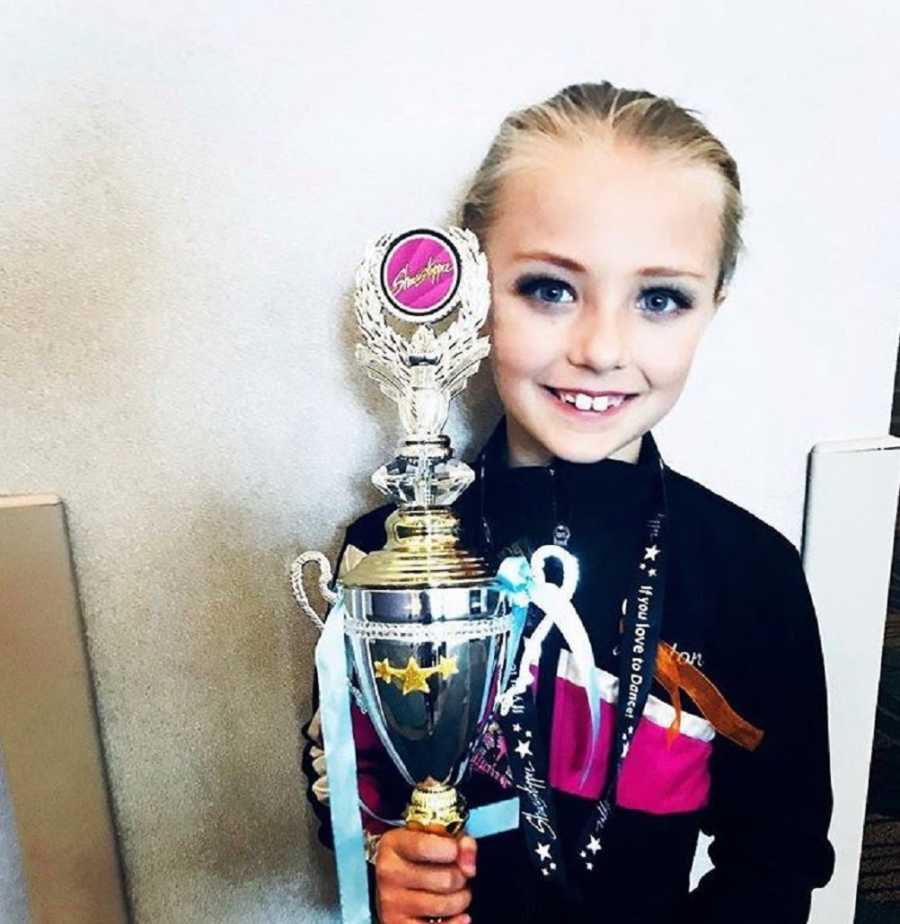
[375,828,477,924]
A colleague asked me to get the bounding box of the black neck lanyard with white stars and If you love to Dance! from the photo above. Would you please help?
[481,458,668,887]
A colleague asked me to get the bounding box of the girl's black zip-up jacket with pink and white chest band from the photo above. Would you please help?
[304,422,834,924]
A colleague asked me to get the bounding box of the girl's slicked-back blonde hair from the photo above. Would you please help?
[460,81,744,297]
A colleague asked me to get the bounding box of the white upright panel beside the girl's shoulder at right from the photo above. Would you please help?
[803,436,900,924]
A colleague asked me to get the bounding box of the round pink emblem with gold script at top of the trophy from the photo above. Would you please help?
[381,230,460,323]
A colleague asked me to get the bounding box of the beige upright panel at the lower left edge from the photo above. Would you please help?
[0,496,127,924]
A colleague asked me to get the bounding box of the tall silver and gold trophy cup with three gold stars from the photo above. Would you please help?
[292,227,516,836]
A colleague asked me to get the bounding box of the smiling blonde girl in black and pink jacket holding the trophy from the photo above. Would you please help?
[304,83,833,924]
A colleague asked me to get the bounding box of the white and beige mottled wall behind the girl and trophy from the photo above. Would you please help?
[0,0,900,924]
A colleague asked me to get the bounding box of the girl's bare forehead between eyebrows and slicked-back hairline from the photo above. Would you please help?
[488,140,724,275]
